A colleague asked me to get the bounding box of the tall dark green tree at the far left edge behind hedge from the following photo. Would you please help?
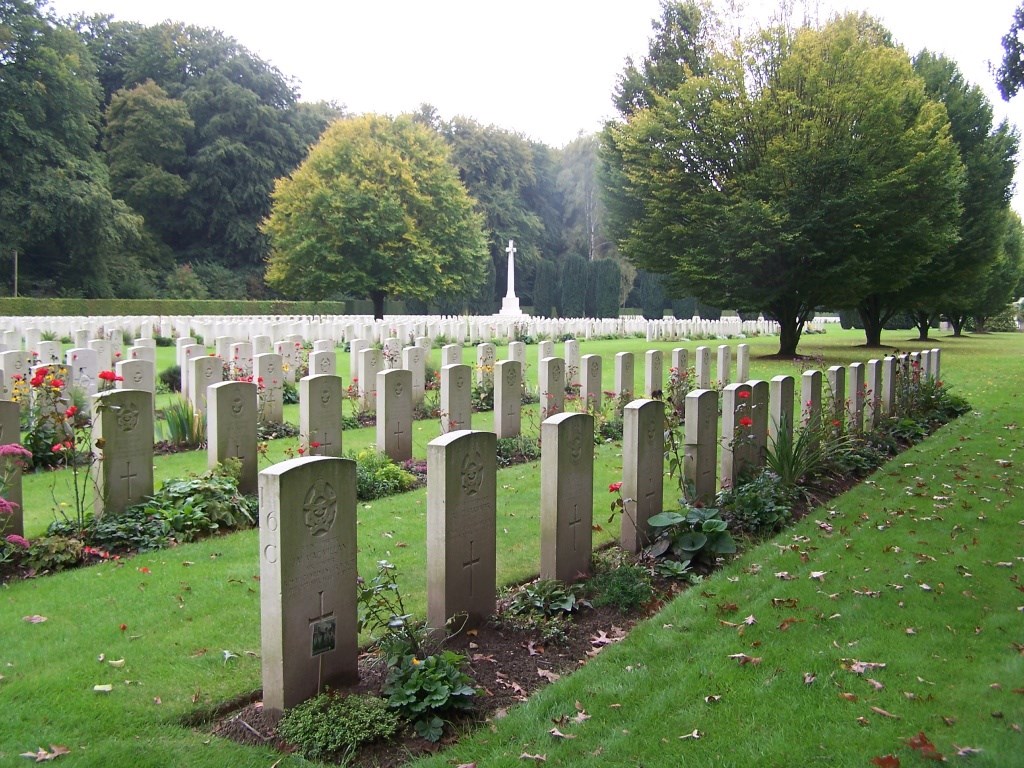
[0,0,141,296]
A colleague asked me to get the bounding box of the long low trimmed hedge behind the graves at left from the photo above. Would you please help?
[0,296,352,317]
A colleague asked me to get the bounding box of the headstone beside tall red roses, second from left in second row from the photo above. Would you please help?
[92,389,153,518]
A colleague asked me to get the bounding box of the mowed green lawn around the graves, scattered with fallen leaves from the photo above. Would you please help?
[0,331,1024,766]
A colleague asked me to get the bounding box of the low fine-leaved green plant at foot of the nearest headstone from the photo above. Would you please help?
[278,693,399,761]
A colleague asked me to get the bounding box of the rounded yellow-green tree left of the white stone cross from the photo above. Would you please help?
[263,115,488,317]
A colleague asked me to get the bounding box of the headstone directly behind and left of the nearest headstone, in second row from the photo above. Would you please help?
[207,381,259,494]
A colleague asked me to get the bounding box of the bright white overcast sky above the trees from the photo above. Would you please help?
[50,0,1024,212]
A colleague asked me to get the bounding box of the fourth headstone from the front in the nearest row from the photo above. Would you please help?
[620,399,665,553]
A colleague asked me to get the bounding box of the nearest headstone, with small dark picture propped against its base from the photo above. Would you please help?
[258,454,358,722]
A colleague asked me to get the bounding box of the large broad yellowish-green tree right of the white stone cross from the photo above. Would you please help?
[602,3,963,355]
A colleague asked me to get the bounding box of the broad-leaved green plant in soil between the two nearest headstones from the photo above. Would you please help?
[384,650,476,741]
